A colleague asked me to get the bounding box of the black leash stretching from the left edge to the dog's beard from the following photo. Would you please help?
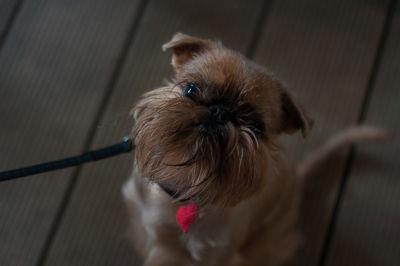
[0,137,133,182]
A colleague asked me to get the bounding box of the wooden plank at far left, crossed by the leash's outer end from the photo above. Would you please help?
[0,0,142,266]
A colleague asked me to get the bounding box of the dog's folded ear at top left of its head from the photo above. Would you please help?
[162,32,212,69]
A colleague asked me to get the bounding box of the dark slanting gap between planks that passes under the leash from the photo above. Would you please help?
[36,0,148,266]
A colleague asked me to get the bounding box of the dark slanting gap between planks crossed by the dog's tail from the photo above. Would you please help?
[318,0,397,266]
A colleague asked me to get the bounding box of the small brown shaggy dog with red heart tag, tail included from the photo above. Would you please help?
[123,33,390,266]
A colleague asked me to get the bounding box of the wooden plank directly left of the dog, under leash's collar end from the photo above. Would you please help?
[43,0,263,266]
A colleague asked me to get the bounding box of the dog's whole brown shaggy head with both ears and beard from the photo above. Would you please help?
[132,33,312,206]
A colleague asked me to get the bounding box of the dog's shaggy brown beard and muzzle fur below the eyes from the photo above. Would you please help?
[133,86,268,206]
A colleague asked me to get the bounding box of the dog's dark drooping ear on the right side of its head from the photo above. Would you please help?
[279,89,314,138]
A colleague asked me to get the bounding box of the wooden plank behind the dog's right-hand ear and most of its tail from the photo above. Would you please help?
[255,0,388,266]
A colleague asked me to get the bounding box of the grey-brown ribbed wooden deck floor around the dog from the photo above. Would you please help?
[0,0,400,266]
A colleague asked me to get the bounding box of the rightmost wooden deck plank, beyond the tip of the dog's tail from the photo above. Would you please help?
[325,5,400,266]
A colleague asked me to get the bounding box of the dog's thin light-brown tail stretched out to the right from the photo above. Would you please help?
[296,125,392,180]
